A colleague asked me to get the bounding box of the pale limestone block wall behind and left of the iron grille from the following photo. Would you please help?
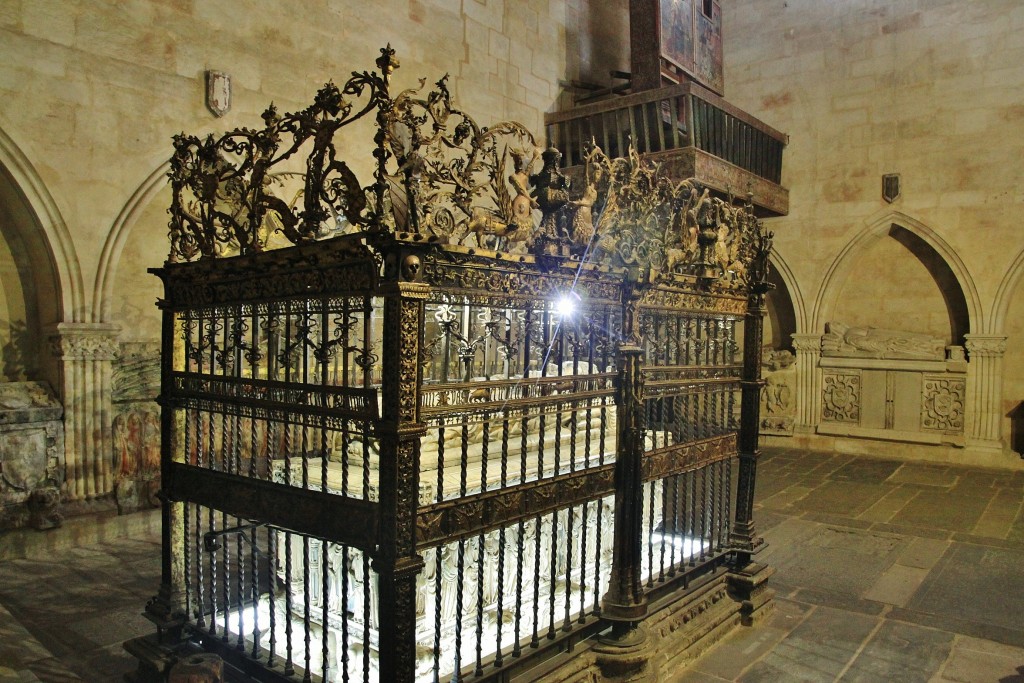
[0,0,587,501]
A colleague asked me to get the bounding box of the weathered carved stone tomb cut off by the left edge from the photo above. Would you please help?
[0,382,65,529]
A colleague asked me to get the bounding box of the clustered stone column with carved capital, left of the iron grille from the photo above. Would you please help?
[49,323,121,501]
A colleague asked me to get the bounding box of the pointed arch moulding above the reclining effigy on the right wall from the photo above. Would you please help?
[810,212,985,333]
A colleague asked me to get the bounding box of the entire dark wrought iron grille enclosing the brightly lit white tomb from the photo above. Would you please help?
[140,50,770,682]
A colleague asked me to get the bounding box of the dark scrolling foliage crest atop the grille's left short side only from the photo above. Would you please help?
[168,47,397,261]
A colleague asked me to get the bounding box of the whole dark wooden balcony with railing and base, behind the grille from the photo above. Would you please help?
[545,83,790,217]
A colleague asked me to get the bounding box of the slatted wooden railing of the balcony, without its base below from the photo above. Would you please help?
[545,83,788,184]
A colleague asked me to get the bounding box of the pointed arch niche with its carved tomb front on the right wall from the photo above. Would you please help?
[798,213,998,459]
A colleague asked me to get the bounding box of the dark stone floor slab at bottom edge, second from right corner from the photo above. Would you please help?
[840,622,953,683]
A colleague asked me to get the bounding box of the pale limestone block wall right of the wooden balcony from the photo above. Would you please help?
[723,0,1024,466]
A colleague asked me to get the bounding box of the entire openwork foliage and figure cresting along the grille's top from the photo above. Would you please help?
[168,47,771,288]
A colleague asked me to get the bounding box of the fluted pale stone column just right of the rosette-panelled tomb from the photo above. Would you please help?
[965,335,1007,451]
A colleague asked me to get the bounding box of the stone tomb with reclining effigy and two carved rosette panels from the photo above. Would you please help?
[818,323,967,445]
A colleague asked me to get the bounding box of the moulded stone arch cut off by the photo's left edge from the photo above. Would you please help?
[0,127,86,325]
